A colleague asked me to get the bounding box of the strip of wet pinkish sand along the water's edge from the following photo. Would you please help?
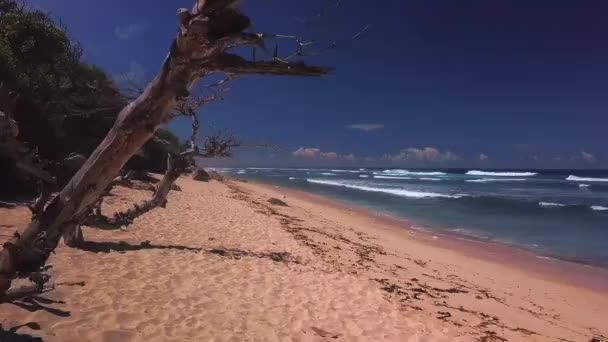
[247,180,608,293]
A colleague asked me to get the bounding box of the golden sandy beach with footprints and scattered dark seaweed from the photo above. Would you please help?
[0,177,608,341]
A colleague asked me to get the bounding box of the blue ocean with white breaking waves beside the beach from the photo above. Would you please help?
[218,168,608,267]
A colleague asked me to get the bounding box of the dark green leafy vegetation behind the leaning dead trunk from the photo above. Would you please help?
[0,0,181,194]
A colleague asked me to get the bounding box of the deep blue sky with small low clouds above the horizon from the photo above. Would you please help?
[29,0,608,168]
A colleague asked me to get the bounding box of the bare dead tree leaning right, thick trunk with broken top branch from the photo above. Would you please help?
[0,0,328,297]
